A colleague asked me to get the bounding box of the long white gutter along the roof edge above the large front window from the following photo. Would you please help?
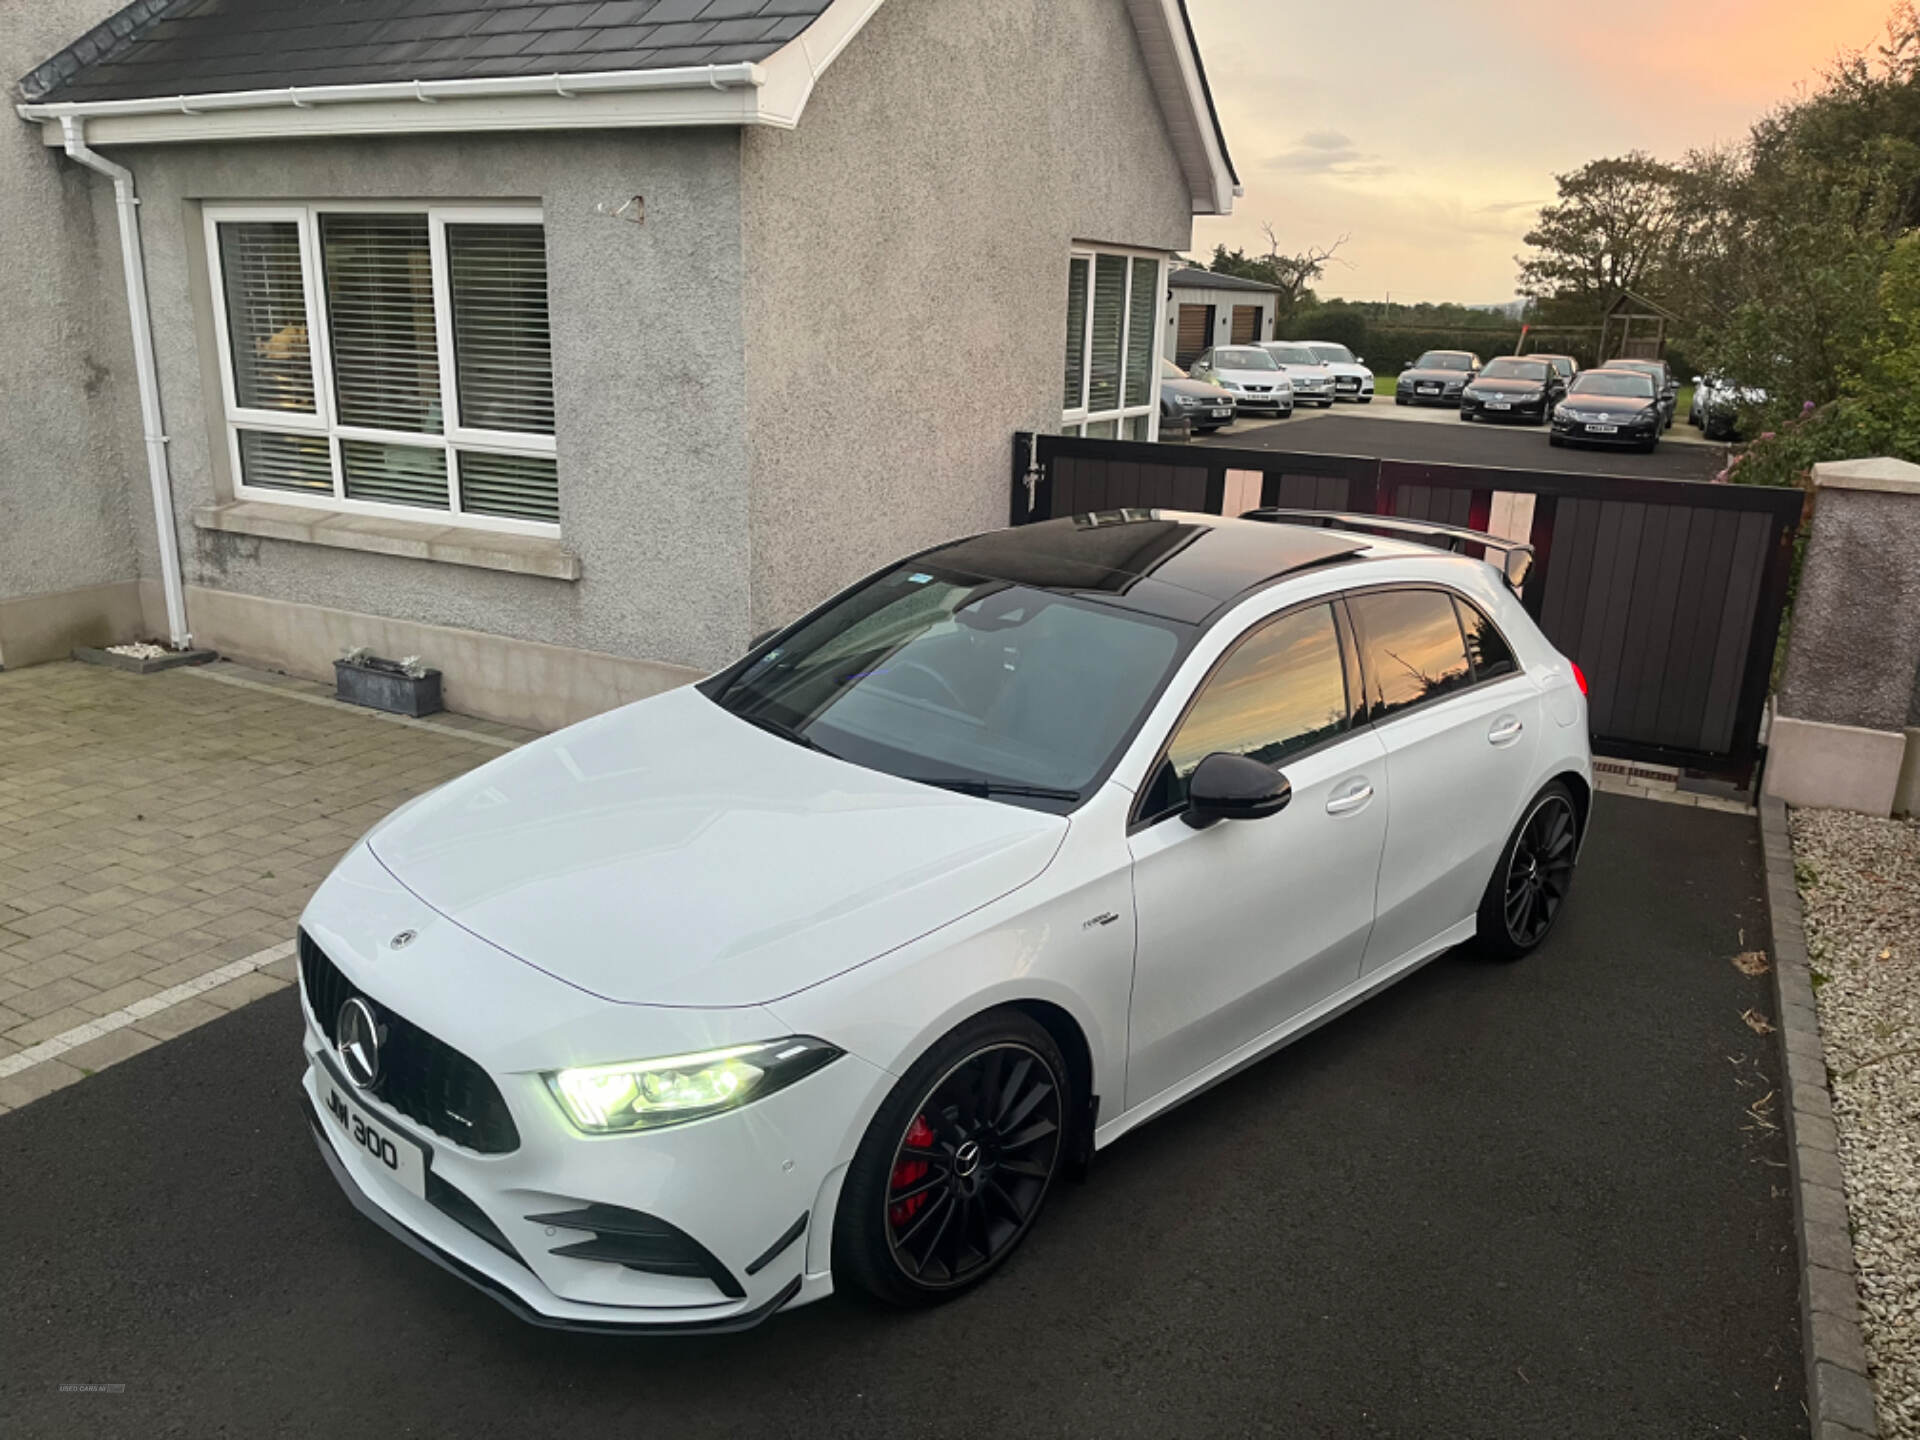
[15,61,766,123]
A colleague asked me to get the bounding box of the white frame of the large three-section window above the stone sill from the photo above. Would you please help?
[202,200,561,538]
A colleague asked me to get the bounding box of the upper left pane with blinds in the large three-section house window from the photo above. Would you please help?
[217,221,313,415]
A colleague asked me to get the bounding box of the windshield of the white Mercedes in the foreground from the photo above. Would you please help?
[708,563,1187,810]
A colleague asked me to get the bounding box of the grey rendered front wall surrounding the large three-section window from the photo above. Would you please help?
[78,127,747,698]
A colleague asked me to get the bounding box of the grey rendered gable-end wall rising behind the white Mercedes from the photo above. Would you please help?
[743,0,1192,628]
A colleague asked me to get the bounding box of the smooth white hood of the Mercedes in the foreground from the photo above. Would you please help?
[369,687,1068,1006]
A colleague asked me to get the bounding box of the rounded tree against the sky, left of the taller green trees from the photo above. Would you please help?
[1515,150,1680,323]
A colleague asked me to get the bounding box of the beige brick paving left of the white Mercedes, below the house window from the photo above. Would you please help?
[0,662,528,1110]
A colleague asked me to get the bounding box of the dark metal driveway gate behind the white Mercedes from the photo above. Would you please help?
[1012,434,1803,772]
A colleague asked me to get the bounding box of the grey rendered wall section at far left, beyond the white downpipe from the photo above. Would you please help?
[0,0,146,664]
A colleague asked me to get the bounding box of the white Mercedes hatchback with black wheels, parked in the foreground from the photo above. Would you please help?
[298,511,1592,1332]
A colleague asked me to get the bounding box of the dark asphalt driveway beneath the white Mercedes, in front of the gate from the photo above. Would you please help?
[0,797,1807,1440]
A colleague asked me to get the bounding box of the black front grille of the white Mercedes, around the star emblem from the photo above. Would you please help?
[300,931,520,1156]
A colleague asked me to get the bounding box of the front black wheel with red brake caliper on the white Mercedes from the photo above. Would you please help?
[833,1008,1079,1306]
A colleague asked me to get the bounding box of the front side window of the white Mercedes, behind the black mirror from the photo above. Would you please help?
[1140,605,1348,816]
